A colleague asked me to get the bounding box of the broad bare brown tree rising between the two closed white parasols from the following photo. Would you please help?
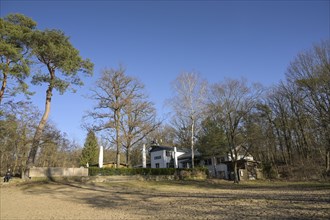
[88,67,155,167]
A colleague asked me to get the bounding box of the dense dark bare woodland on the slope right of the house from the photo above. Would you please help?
[255,41,330,178]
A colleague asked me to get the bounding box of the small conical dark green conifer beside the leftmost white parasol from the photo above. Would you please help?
[80,131,98,165]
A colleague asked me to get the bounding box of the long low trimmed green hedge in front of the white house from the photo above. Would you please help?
[88,167,208,176]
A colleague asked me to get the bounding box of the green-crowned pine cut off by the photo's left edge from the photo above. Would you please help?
[0,14,36,104]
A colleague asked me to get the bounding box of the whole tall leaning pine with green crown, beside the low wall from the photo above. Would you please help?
[25,26,93,176]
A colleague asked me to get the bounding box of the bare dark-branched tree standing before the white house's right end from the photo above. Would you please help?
[210,79,261,183]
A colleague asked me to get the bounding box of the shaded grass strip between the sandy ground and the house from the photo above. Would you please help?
[15,177,330,192]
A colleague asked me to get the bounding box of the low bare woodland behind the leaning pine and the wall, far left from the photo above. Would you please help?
[0,102,81,175]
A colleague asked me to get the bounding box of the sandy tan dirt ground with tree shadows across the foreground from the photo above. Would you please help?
[0,180,330,220]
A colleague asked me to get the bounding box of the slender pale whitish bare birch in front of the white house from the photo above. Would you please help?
[171,72,207,168]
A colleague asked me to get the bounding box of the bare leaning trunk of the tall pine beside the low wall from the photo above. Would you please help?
[25,84,53,177]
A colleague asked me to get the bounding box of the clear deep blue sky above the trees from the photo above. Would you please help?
[0,0,330,144]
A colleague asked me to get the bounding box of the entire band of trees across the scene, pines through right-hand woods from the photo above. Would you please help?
[0,15,330,178]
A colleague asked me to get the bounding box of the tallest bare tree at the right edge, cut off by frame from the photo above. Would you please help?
[286,40,330,172]
